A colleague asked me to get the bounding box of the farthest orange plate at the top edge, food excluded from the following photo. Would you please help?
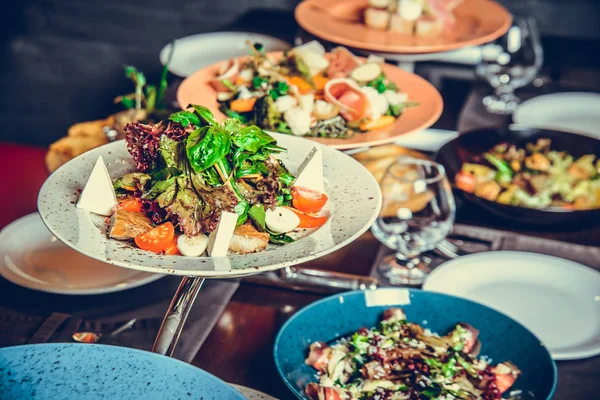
[296,0,512,54]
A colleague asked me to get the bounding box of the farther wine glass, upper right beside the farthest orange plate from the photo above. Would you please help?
[475,17,544,115]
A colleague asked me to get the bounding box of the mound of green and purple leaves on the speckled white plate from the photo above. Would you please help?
[123,105,295,239]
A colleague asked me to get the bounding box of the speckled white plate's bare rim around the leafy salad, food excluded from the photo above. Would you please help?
[38,134,382,278]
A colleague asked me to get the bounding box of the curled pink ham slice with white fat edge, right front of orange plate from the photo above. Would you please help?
[325,79,371,121]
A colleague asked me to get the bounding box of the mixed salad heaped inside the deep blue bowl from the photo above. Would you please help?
[306,308,520,400]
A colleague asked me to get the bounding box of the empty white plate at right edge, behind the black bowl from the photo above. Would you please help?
[513,92,600,138]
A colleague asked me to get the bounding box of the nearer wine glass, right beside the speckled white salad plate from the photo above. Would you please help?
[371,157,456,285]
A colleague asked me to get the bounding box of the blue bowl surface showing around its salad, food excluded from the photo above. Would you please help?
[274,289,557,400]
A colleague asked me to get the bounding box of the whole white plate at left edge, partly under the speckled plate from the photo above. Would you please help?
[0,213,163,294]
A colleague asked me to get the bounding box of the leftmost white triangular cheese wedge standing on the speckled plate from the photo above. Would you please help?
[77,156,117,216]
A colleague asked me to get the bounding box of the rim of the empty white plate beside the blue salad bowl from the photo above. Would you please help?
[423,251,600,360]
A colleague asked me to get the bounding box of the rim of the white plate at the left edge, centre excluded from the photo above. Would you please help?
[0,212,164,295]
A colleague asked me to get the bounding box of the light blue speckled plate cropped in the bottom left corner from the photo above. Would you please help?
[0,343,244,400]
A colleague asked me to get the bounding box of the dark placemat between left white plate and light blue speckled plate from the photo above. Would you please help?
[0,276,239,362]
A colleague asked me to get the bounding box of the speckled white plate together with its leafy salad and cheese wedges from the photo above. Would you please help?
[38,106,381,278]
